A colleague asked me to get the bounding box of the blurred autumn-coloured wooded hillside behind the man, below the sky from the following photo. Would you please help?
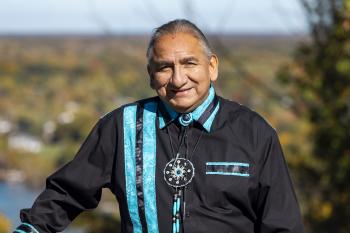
[0,35,306,187]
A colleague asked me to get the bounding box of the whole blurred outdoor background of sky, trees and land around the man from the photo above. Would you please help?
[0,0,350,233]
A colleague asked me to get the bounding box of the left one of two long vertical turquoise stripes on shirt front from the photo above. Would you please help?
[123,105,142,233]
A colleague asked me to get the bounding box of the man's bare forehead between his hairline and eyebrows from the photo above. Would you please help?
[153,32,204,59]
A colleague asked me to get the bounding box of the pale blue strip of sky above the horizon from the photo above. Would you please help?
[0,0,307,34]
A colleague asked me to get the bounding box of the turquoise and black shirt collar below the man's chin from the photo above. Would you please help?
[158,86,219,132]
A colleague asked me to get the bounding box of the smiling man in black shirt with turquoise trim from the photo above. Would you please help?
[15,20,303,233]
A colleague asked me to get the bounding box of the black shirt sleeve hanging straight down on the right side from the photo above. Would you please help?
[258,131,304,233]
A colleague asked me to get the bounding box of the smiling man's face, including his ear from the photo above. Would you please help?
[147,32,218,112]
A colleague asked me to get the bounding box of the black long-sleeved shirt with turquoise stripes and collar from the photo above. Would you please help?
[18,88,303,233]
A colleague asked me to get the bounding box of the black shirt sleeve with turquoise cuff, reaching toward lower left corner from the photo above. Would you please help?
[15,115,117,233]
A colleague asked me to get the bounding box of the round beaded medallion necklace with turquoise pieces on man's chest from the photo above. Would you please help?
[163,113,204,233]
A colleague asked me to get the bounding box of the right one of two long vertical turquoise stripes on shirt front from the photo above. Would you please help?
[142,102,159,233]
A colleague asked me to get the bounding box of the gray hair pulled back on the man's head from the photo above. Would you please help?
[146,19,212,64]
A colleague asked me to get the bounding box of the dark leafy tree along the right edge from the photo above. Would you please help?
[278,0,350,233]
